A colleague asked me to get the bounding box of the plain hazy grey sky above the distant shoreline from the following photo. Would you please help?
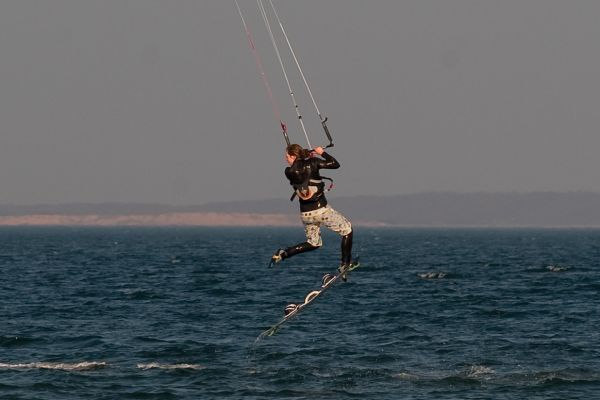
[0,0,600,204]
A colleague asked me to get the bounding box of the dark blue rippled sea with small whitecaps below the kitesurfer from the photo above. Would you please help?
[0,228,600,400]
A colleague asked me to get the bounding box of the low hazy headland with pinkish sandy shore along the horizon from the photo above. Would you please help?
[0,192,600,228]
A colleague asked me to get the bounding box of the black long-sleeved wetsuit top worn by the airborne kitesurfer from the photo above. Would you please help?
[285,153,340,212]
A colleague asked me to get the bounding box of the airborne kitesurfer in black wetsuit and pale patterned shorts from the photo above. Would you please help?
[271,144,353,270]
